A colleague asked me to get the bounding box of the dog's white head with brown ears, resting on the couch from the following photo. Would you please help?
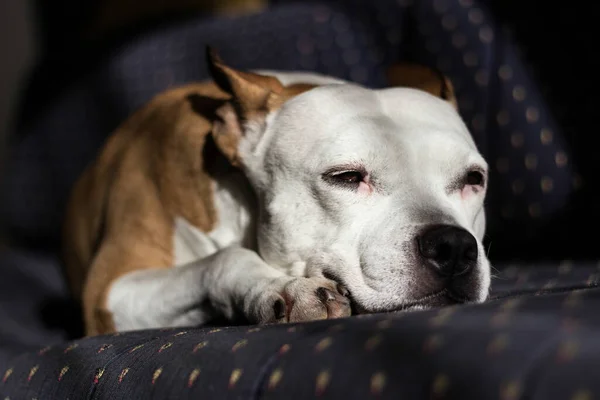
[209,49,490,312]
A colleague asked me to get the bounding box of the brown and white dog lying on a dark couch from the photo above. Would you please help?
[64,48,490,335]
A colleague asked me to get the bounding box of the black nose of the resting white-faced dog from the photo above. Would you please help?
[418,225,477,277]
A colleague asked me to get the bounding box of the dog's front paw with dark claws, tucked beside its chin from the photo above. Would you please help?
[257,277,351,324]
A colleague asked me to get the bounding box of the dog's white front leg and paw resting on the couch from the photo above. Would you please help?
[107,247,350,331]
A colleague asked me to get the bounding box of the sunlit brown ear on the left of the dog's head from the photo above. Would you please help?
[206,47,285,166]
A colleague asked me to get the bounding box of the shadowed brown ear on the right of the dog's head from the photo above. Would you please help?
[387,63,458,109]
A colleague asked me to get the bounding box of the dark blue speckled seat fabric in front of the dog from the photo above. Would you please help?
[0,263,600,400]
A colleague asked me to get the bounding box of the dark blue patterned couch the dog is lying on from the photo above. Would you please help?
[0,0,600,400]
